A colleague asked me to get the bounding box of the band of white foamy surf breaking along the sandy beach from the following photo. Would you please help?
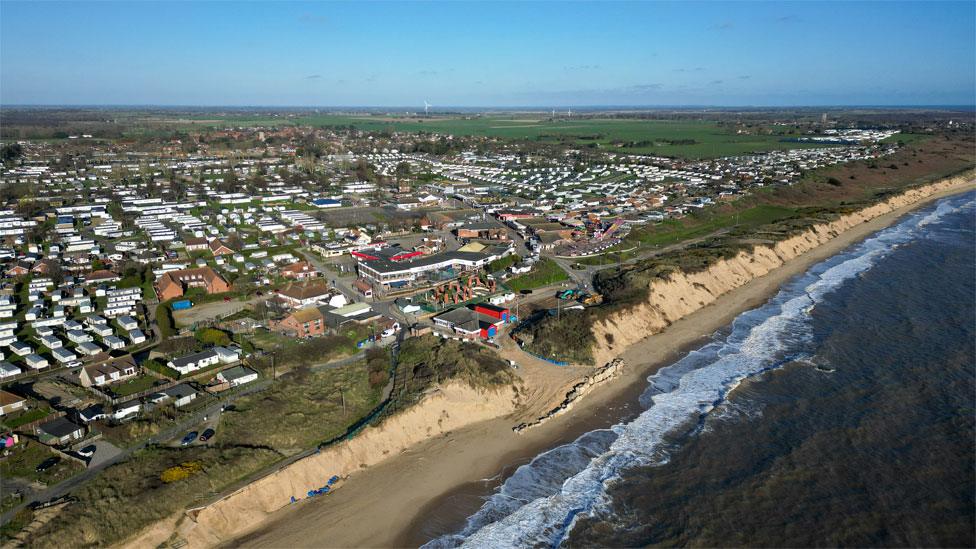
[426,194,976,547]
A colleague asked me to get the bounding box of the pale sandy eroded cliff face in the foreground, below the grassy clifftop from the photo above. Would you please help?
[125,383,519,547]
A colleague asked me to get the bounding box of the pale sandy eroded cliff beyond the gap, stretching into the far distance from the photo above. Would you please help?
[593,175,973,364]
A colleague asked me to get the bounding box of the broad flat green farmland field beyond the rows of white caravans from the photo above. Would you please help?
[154,114,823,158]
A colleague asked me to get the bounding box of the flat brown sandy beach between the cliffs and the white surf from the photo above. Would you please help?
[225,180,974,547]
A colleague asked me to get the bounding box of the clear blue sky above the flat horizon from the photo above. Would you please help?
[0,0,976,107]
